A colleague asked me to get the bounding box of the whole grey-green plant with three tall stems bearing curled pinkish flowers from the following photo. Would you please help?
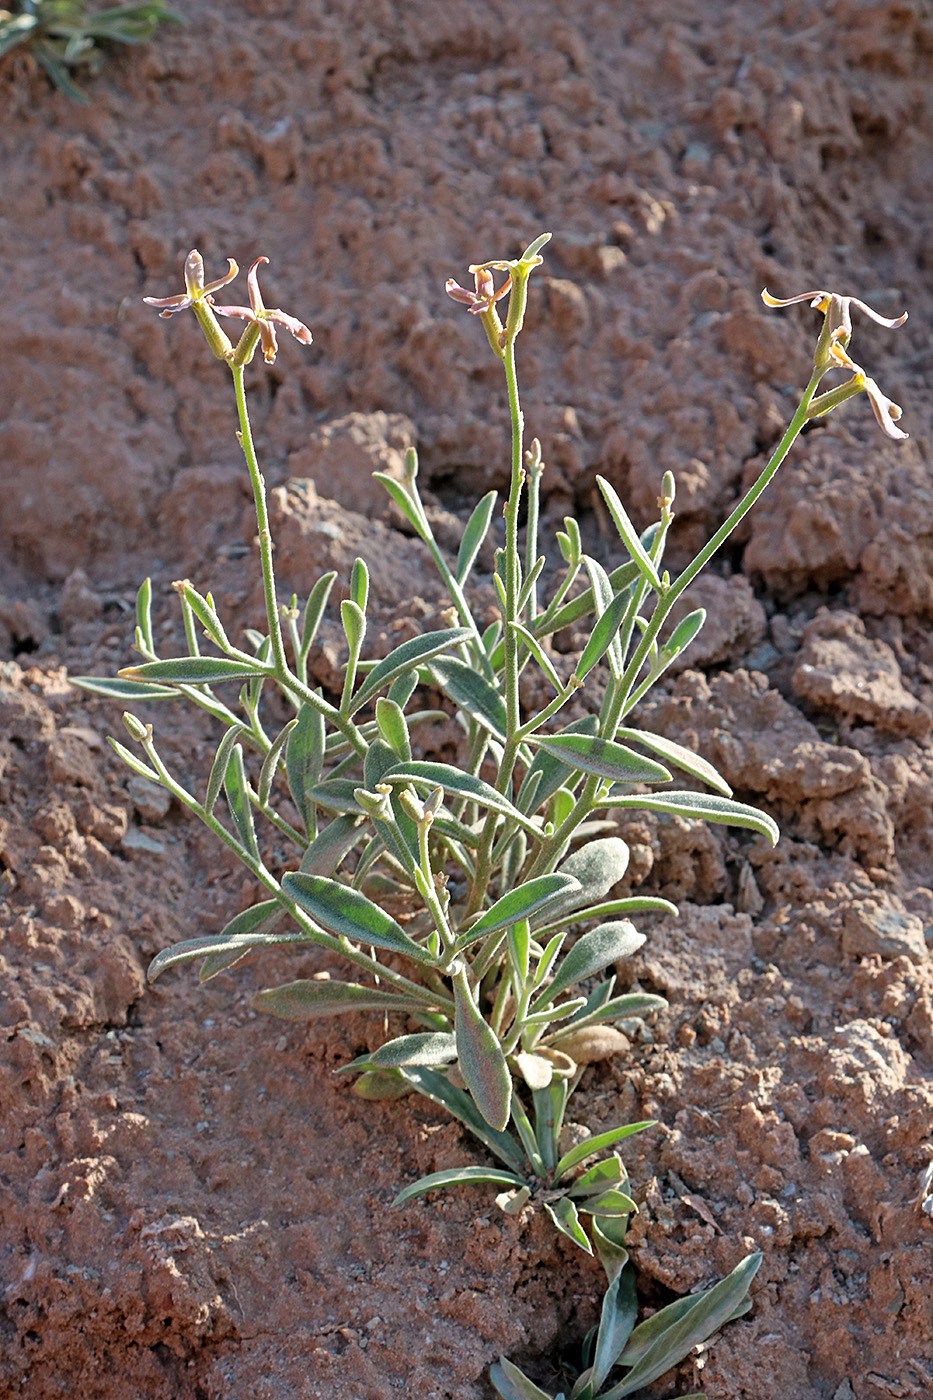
[78,243,904,1400]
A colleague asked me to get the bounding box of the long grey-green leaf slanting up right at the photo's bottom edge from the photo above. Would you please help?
[601,1252,762,1400]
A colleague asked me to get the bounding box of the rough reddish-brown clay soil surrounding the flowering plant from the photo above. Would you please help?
[0,0,933,1400]
